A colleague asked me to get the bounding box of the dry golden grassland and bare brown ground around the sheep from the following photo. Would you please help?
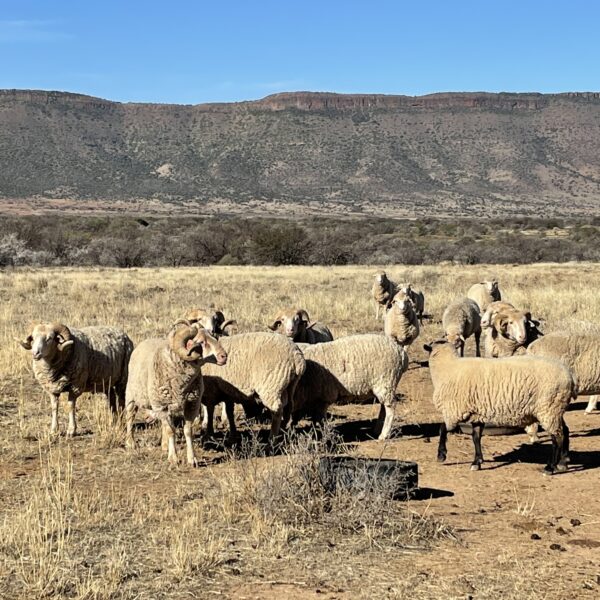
[0,264,600,599]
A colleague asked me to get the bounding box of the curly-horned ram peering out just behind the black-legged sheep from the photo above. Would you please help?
[481,301,542,358]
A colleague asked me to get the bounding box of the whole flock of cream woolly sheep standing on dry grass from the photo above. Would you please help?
[17,272,600,474]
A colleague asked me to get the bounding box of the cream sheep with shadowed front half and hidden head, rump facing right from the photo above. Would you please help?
[293,334,408,440]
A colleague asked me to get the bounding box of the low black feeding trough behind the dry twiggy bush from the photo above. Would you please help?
[319,456,419,499]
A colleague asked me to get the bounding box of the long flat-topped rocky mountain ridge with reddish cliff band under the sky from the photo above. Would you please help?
[0,90,600,215]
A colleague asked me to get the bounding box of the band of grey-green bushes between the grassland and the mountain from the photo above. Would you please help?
[0,216,600,268]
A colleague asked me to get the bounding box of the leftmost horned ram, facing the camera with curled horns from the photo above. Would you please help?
[17,323,133,437]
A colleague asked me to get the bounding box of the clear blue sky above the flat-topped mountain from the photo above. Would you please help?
[0,0,600,104]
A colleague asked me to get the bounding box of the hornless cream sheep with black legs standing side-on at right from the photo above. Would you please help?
[424,340,577,474]
